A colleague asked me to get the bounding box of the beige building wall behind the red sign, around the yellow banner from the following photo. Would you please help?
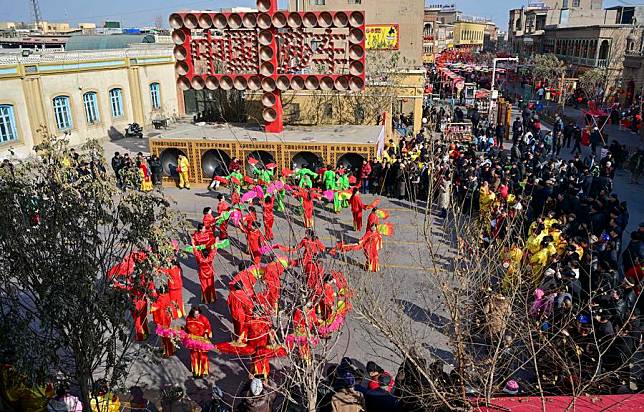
[288,0,425,67]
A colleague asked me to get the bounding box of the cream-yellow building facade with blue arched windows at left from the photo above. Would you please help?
[0,48,183,157]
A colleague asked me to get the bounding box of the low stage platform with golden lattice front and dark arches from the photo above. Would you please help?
[148,123,385,184]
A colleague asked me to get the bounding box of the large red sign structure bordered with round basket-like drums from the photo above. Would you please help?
[170,0,366,133]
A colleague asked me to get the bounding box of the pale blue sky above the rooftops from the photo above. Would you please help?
[0,0,624,28]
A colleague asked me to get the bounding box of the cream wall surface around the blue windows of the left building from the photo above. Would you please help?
[0,52,180,158]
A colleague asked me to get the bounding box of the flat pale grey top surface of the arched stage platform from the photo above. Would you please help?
[149,123,383,144]
